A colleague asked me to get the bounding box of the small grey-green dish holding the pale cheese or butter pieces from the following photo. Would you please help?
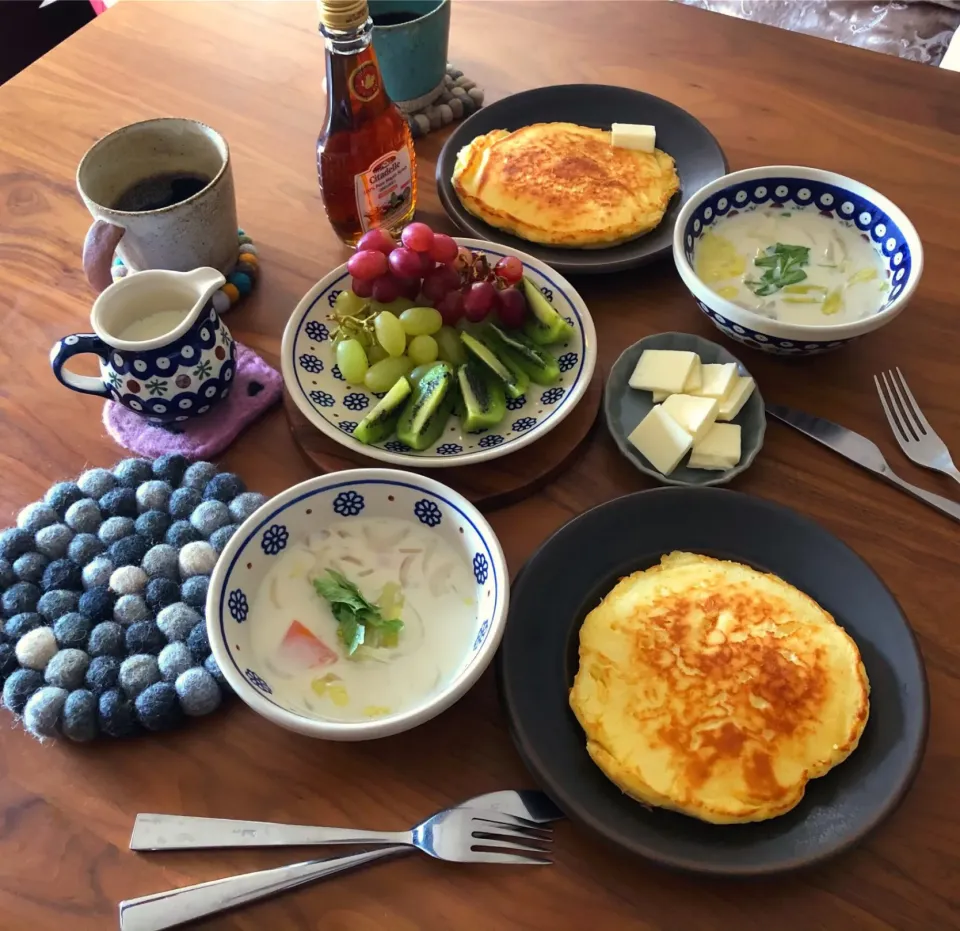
[603,333,767,487]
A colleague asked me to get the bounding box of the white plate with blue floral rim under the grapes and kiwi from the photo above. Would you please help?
[281,238,597,468]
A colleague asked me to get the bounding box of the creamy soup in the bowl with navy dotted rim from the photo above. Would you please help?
[694,208,890,326]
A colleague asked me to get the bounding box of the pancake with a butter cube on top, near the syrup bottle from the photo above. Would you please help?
[452,123,680,248]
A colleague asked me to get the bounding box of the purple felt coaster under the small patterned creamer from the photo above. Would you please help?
[103,343,283,459]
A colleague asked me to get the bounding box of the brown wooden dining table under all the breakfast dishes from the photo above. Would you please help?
[0,0,960,931]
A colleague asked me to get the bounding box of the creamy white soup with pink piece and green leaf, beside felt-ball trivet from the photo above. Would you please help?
[250,517,477,721]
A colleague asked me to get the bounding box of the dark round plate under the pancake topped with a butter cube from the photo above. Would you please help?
[437,84,727,275]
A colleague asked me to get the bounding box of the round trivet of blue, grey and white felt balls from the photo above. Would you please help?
[0,455,258,742]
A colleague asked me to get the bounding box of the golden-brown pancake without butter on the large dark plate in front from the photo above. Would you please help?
[570,553,870,824]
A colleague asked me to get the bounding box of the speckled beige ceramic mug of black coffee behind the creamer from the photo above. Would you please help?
[77,118,237,291]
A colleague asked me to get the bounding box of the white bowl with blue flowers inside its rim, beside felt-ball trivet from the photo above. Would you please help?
[206,469,510,740]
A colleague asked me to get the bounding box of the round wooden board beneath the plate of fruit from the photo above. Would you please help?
[283,365,603,510]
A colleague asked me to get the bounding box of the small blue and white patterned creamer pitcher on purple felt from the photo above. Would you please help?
[50,268,236,424]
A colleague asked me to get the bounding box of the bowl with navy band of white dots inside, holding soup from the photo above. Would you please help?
[673,165,923,356]
